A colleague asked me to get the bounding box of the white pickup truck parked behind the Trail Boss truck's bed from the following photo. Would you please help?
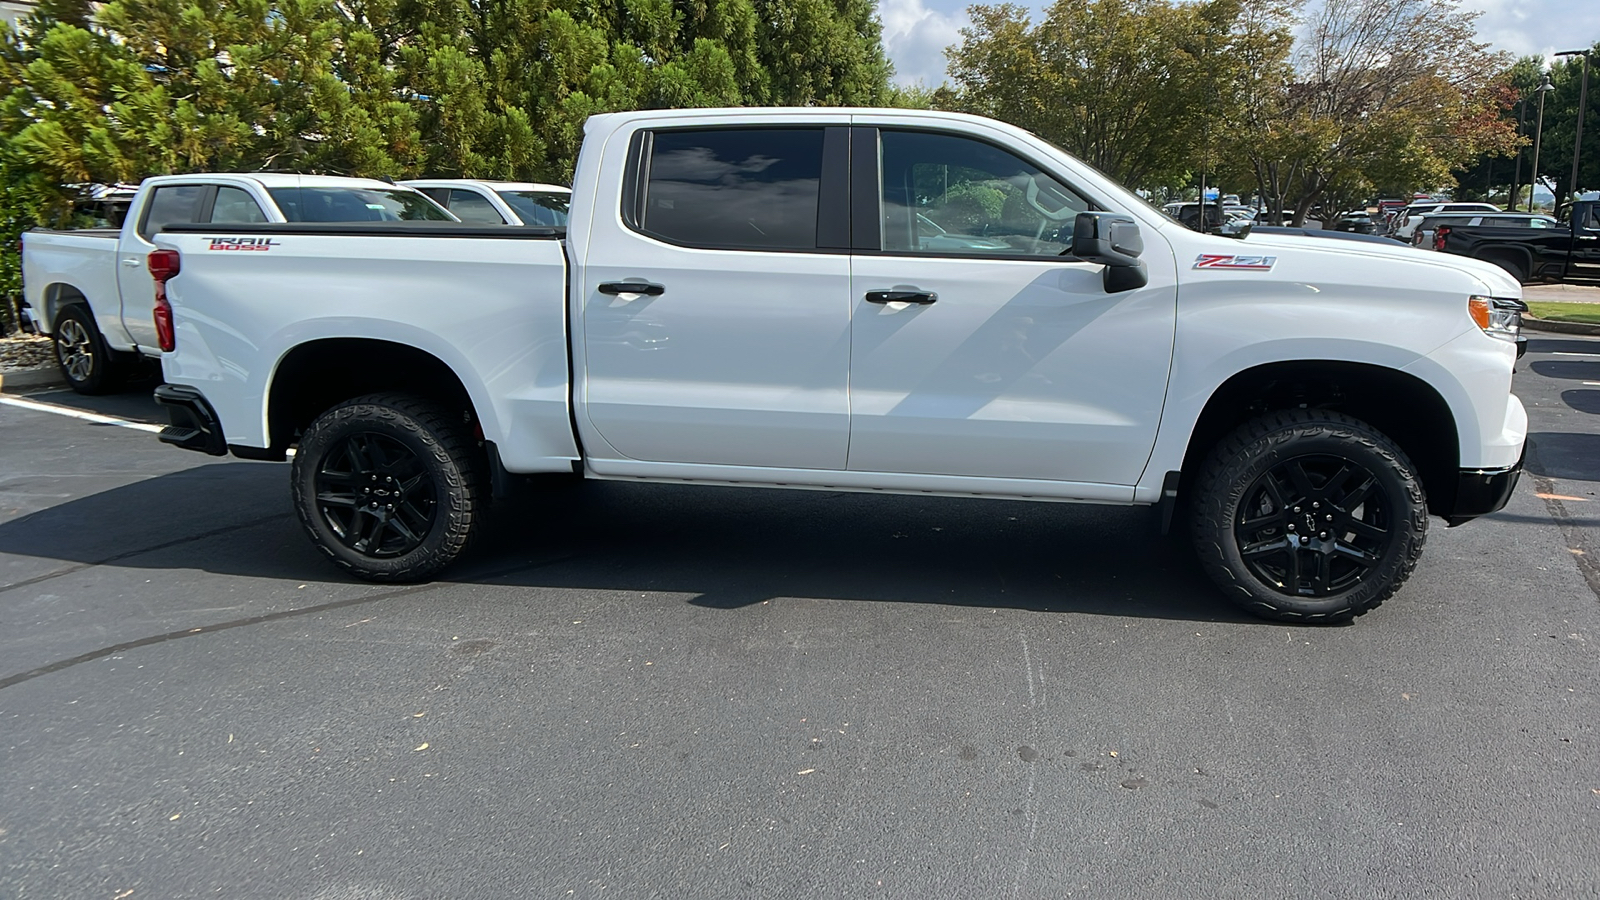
[22,173,454,394]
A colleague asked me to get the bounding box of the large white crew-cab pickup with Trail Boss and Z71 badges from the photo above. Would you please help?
[150,109,1526,621]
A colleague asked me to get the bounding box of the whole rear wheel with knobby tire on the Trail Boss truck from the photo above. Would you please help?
[291,394,483,581]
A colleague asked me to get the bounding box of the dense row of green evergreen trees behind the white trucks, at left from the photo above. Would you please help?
[0,0,890,320]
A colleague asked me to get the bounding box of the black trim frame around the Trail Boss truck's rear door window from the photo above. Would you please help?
[621,123,853,256]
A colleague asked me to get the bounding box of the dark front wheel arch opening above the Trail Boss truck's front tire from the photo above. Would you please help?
[1179,360,1461,516]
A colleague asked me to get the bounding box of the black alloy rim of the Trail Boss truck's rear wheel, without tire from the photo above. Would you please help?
[315,431,438,559]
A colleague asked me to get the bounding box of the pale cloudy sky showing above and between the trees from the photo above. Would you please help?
[878,0,1600,86]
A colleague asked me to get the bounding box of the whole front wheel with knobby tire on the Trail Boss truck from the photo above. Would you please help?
[1190,410,1427,623]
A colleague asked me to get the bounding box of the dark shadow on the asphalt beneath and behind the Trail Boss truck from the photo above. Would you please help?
[0,461,1266,625]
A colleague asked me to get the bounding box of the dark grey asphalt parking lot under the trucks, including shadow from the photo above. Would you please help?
[0,335,1600,900]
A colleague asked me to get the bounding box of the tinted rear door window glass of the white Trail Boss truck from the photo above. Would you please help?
[637,128,822,250]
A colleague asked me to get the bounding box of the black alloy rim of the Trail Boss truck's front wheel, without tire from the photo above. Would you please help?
[1234,455,1395,597]
